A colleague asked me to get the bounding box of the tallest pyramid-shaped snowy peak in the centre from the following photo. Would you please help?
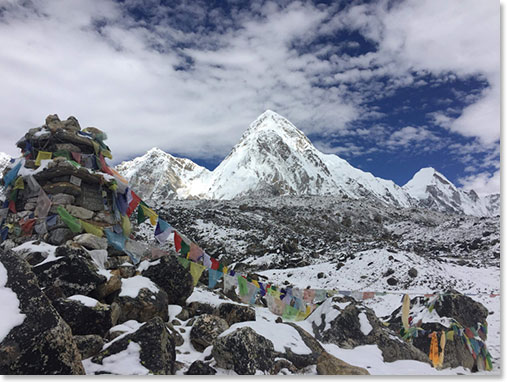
[207,110,410,206]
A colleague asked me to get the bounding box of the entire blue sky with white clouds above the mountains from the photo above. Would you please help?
[0,0,500,194]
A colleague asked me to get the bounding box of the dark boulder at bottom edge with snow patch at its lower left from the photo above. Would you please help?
[91,317,176,374]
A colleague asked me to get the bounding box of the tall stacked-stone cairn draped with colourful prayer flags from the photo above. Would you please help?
[0,115,134,254]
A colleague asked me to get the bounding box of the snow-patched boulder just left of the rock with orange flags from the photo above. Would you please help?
[307,297,429,363]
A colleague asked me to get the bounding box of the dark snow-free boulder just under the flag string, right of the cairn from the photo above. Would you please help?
[142,256,194,305]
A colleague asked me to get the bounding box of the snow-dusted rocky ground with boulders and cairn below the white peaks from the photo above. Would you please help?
[0,115,500,375]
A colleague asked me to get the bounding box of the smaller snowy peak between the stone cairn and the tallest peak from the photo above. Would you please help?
[116,148,209,202]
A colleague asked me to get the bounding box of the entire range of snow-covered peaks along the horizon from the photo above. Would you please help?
[117,110,496,216]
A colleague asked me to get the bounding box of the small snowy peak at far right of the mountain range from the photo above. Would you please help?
[403,167,499,216]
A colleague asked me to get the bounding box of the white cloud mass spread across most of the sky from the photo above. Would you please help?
[0,0,499,173]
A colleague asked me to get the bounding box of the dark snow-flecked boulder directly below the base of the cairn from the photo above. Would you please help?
[33,246,106,297]
